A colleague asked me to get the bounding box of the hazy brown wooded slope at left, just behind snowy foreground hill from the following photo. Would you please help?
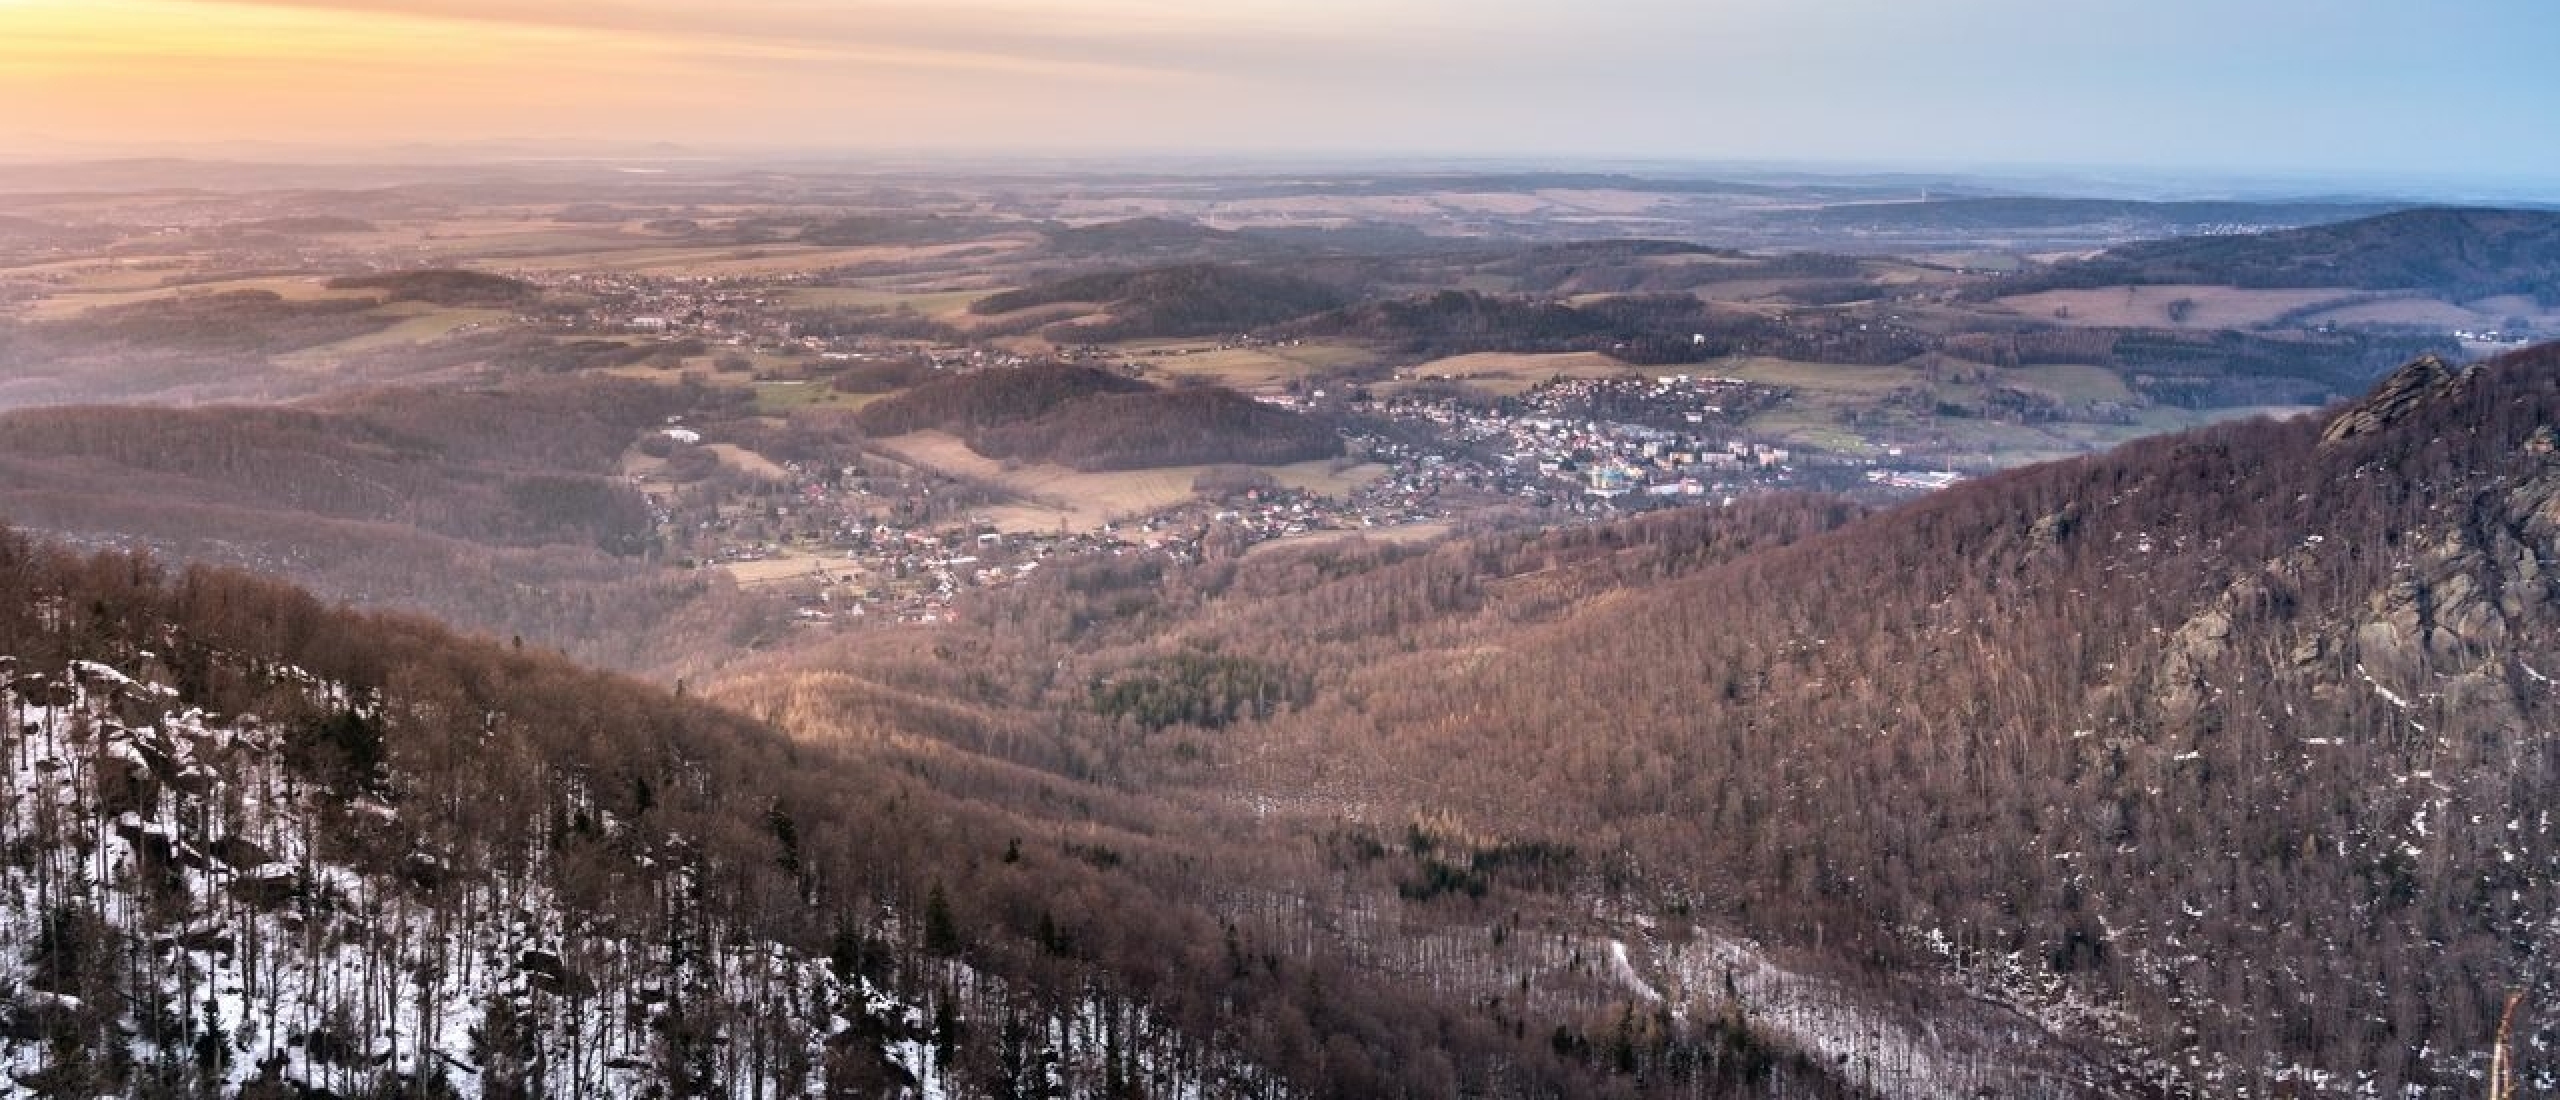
[0,379,763,668]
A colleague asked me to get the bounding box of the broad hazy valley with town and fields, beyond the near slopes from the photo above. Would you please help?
[0,169,2519,670]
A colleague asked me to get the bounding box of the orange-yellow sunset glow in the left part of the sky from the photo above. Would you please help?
[0,0,1192,143]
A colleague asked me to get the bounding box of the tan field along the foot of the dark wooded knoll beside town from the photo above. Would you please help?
[881,432,1385,532]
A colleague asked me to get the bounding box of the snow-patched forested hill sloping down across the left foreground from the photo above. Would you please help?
[0,530,1838,1097]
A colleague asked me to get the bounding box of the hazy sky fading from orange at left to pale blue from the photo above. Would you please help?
[0,0,2560,182]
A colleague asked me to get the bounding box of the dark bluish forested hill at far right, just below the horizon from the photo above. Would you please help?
[2038,207,2560,307]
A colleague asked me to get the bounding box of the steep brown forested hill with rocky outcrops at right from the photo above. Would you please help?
[1244,345,2560,1095]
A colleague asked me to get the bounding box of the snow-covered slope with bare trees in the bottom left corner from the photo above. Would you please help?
[0,657,1277,1097]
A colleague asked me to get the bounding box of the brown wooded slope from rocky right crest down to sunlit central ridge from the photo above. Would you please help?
[803,345,2560,1097]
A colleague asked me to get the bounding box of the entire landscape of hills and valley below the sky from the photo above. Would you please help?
[0,164,2560,1097]
